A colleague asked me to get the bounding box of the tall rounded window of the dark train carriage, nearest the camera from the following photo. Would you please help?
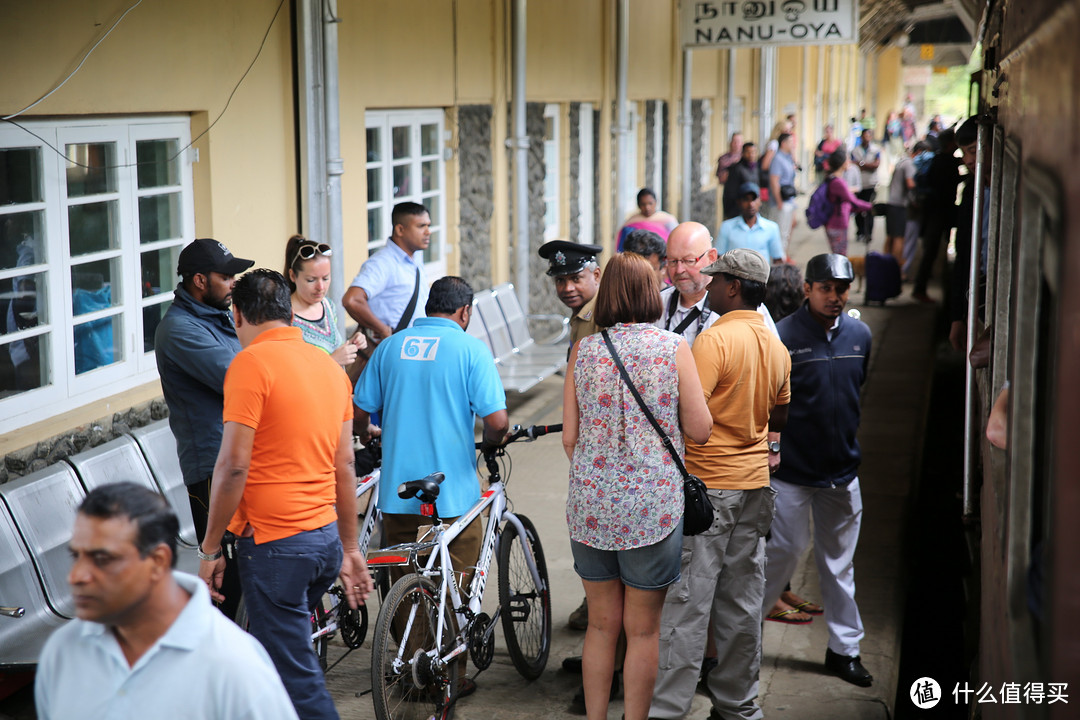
[1008,166,1062,660]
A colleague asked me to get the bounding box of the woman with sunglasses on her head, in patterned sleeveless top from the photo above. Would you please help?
[284,235,367,369]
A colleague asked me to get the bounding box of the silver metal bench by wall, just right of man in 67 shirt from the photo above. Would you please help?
[473,286,566,393]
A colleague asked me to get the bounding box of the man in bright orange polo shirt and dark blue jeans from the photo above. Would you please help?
[199,270,372,720]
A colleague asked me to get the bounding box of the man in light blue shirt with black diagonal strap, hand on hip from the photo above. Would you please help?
[341,203,431,342]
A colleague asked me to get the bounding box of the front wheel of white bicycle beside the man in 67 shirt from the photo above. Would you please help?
[499,515,551,680]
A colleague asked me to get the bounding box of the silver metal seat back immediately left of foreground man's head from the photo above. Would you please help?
[0,463,86,619]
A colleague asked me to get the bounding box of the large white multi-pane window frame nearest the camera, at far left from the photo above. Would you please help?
[0,116,194,433]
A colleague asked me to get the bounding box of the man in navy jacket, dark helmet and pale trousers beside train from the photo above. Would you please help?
[764,255,873,688]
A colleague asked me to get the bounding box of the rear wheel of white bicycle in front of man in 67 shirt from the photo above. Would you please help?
[372,574,458,720]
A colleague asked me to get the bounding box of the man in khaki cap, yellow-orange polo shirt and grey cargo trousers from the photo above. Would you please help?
[649,248,792,720]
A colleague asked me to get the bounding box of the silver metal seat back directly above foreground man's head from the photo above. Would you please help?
[67,435,199,574]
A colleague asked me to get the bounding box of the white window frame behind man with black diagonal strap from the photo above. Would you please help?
[364,109,450,279]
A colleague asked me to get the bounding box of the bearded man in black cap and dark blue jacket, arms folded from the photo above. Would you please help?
[154,237,255,617]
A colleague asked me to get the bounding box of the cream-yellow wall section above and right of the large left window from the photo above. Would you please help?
[0,0,297,273]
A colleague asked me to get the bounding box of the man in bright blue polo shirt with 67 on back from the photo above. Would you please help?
[353,275,509,697]
